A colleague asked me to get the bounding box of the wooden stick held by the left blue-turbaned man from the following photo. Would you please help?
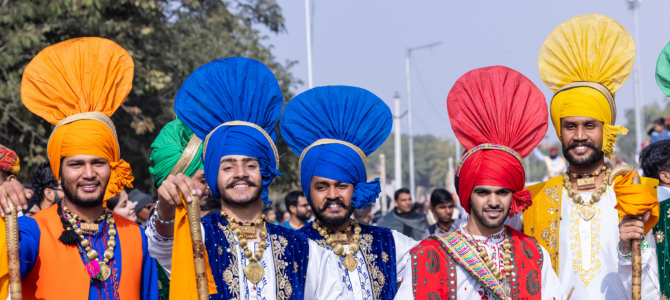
[186,195,209,300]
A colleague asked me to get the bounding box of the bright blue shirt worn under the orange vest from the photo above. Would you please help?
[18,216,158,300]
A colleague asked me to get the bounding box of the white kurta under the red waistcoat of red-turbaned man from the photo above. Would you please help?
[395,223,564,300]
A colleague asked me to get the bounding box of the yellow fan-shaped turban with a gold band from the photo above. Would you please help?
[538,14,635,158]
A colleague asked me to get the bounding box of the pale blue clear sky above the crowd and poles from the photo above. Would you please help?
[266,0,670,140]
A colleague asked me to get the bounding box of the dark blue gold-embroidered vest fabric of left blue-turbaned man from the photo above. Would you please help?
[201,214,309,300]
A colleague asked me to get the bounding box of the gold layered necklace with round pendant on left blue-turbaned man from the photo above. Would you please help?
[221,210,268,284]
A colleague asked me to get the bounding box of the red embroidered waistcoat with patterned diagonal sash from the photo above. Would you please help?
[410,226,544,300]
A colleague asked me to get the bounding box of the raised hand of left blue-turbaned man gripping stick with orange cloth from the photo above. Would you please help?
[158,174,202,221]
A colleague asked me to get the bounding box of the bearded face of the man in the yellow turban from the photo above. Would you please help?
[561,117,604,166]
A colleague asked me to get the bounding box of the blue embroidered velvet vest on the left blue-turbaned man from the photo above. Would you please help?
[202,213,309,300]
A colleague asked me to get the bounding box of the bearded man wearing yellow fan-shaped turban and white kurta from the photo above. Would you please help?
[510,15,660,299]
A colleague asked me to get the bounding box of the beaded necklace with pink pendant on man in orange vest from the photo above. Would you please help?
[62,202,116,281]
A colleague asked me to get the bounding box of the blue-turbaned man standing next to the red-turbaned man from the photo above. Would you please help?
[281,86,417,300]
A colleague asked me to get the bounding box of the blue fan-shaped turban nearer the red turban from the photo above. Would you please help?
[280,86,393,208]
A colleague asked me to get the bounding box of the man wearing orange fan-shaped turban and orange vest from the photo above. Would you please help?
[0,38,158,300]
